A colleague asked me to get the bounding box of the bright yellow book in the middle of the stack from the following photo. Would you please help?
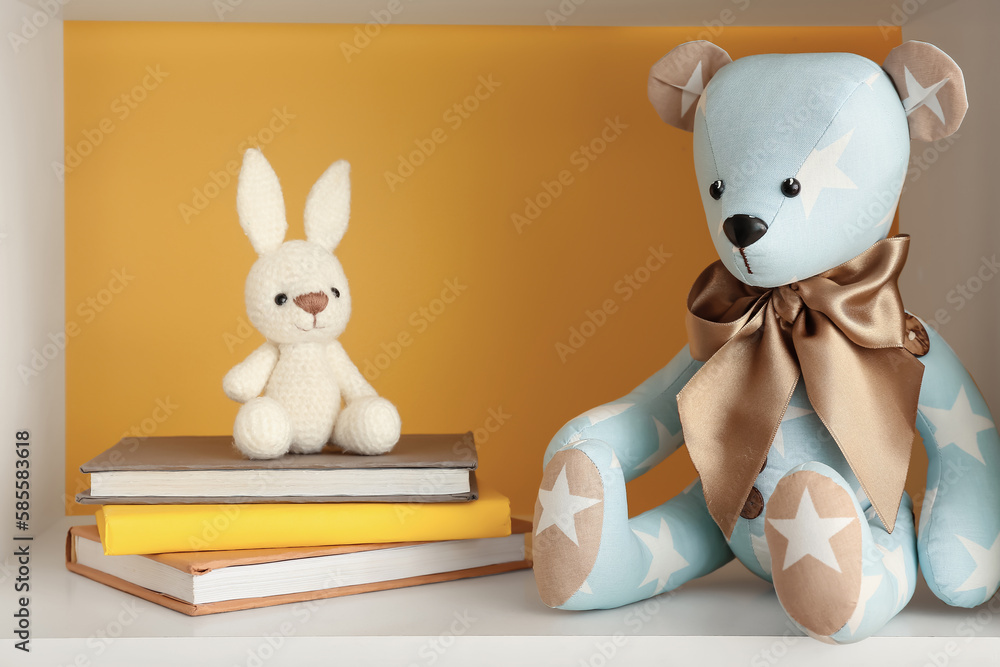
[97,483,510,556]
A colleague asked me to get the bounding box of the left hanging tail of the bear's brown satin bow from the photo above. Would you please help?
[677,307,799,539]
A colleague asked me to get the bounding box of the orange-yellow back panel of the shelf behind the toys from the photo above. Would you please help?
[64,22,900,513]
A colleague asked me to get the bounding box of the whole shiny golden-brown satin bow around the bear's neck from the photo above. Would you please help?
[677,235,924,538]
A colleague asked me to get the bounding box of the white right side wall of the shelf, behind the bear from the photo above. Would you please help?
[904,0,1000,415]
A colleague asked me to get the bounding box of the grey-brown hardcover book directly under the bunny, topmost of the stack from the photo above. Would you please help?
[76,433,478,505]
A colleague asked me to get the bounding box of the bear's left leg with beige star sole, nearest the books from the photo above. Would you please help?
[532,440,733,609]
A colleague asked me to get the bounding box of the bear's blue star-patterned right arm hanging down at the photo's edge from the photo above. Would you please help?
[917,323,1000,607]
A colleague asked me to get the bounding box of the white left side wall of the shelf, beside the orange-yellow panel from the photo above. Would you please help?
[0,2,66,532]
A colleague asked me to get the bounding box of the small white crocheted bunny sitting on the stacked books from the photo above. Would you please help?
[222,148,400,459]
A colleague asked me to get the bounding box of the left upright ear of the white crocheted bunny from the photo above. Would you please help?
[236,148,288,255]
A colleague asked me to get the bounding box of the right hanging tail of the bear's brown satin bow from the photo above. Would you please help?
[793,316,924,533]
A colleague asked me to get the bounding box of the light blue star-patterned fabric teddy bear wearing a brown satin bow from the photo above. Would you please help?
[533,41,1000,644]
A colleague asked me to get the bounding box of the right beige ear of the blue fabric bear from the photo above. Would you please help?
[882,41,969,141]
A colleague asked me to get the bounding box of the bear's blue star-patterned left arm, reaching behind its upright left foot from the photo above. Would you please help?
[544,345,702,481]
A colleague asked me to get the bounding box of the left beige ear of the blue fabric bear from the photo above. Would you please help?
[646,40,733,132]
